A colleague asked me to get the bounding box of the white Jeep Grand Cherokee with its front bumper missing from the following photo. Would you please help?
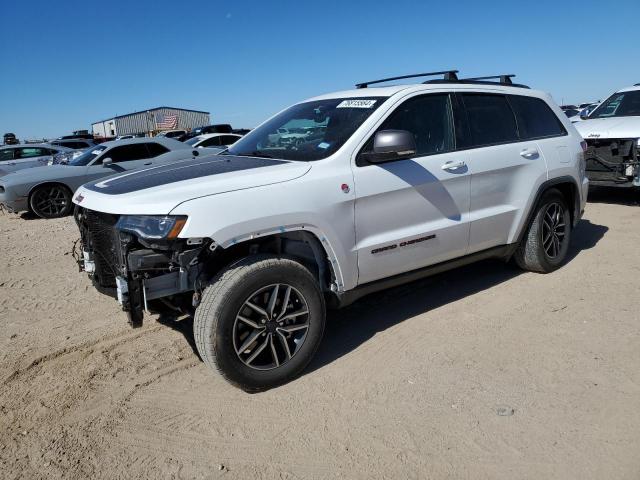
[74,71,588,391]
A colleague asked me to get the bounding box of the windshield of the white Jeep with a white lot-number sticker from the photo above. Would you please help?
[225,97,385,162]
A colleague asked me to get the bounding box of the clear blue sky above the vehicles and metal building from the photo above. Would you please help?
[0,0,640,138]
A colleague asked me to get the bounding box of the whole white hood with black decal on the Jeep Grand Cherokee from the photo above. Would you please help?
[73,155,311,215]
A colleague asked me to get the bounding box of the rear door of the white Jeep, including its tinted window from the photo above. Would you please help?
[459,93,547,253]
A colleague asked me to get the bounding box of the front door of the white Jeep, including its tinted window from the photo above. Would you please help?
[354,93,470,284]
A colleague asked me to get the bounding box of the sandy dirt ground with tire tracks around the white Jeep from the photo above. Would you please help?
[0,191,640,479]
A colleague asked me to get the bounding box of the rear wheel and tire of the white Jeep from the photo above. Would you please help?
[514,188,571,273]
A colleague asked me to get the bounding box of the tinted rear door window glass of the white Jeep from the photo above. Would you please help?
[462,93,519,147]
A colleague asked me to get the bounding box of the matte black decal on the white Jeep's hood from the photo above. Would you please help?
[85,155,288,195]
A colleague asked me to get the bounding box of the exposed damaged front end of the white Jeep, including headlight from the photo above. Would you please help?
[74,207,210,327]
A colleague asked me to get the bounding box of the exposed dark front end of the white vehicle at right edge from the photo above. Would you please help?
[585,138,640,187]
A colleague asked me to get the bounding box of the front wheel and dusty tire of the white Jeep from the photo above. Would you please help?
[193,255,325,392]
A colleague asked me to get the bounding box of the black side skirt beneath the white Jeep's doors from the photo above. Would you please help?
[332,243,518,308]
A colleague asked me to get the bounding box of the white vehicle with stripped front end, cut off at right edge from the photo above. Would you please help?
[576,83,640,187]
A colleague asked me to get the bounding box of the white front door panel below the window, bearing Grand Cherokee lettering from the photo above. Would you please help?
[355,152,471,283]
